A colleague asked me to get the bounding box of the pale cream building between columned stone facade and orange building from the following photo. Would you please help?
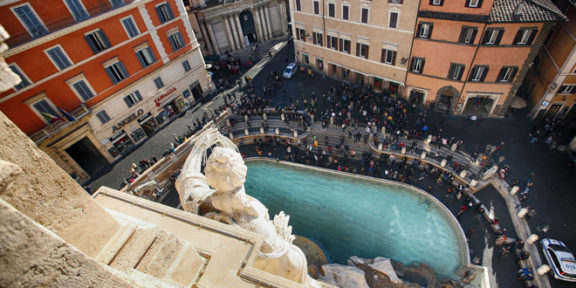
[290,0,418,94]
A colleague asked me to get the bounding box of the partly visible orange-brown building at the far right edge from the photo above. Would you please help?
[525,1,576,119]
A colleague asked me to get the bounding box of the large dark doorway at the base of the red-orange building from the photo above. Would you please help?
[65,137,108,176]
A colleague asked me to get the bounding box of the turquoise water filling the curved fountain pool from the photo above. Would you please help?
[246,161,465,278]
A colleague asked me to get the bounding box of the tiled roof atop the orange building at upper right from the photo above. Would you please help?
[490,0,568,23]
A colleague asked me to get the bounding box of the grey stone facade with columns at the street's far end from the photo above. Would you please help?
[185,0,288,55]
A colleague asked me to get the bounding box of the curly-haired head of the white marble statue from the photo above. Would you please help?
[204,147,248,192]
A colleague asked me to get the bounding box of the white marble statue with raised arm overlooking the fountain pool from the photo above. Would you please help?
[175,128,320,287]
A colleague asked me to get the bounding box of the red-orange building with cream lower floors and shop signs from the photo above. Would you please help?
[0,0,212,182]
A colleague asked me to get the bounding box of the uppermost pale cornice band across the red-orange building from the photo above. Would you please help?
[4,0,153,58]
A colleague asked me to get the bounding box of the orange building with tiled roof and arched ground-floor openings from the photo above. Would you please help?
[406,0,567,116]
